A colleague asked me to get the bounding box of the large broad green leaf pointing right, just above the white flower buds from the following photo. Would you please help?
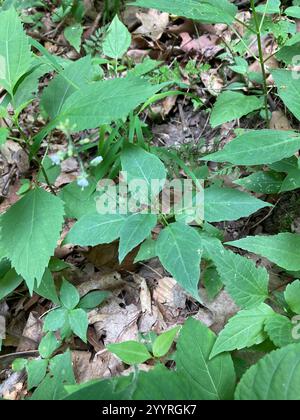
[57,76,161,132]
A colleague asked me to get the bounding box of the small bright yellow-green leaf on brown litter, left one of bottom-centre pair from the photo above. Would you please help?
[106,341,152,365]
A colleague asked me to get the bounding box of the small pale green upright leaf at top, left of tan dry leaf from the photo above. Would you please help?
[102,15,131,60]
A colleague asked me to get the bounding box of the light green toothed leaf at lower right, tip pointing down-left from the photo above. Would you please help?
[210,303,275,358]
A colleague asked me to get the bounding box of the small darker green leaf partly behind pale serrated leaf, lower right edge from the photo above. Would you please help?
[265,314,296,347]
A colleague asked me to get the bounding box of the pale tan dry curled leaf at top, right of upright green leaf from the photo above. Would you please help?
[135,9,169,41]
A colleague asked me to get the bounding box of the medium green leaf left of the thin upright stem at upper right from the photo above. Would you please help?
[210,91,263,127]
